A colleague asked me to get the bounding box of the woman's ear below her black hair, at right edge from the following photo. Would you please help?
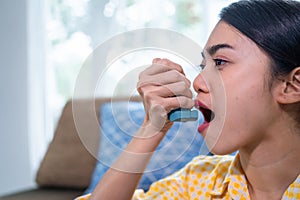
[276,67,300,104]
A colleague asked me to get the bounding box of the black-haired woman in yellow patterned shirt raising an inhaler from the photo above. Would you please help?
[78,0,300,199]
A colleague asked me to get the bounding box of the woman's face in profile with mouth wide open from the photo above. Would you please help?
[194,21,275,154]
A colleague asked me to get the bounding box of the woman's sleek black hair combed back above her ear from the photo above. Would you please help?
[220,0,300,78]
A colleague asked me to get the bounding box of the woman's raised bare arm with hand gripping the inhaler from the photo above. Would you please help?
[92,59,194,199]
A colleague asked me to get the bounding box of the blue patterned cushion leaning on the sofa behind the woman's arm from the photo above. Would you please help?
[85,102,208,193]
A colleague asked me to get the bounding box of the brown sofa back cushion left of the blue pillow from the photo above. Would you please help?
[36,97,140,188]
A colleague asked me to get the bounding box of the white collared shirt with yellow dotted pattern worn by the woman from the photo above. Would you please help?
[77,154,300,200]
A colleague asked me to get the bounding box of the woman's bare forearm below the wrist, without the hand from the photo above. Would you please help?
[92,127,165,200]
